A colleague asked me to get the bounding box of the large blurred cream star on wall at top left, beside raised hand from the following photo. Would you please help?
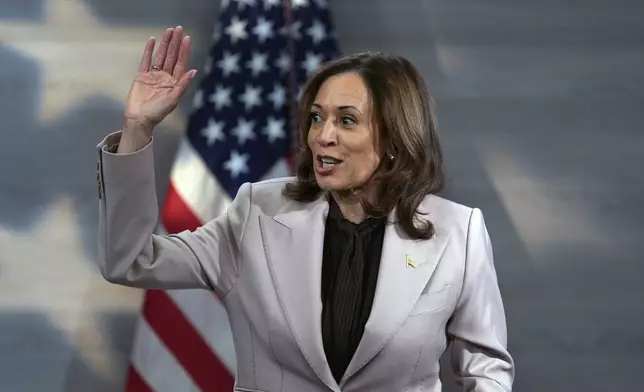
[0,0,166,125]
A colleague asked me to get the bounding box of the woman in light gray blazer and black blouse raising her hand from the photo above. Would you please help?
[98,28,514,392]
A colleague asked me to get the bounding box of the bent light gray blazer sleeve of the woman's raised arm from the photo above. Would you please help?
[97,132,251,296]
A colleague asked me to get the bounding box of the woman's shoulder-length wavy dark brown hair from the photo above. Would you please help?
[283,53,444,239]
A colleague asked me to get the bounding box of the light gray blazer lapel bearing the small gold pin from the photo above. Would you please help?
[341,214,449,385]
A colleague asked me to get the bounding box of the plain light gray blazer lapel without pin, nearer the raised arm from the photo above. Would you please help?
[260,197,338,390]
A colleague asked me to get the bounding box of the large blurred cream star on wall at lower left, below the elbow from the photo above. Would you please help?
[0,198,141,380]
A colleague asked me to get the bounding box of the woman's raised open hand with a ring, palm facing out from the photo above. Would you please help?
[125,26,196,130]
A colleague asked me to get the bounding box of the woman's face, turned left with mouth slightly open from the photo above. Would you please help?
[308,73,380,191]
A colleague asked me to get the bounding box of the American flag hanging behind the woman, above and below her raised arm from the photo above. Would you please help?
[126,0,339,392]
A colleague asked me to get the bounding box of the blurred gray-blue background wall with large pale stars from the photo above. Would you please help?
[0,0,644,392]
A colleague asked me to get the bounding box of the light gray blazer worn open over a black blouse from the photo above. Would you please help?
[98,133,514,392]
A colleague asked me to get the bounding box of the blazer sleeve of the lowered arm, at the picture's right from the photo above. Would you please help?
[447,208,514,392]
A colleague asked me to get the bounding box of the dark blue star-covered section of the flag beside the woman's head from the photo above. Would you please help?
[187,0,339,198]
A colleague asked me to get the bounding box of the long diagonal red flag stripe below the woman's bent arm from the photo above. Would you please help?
[143,290,234,392]
